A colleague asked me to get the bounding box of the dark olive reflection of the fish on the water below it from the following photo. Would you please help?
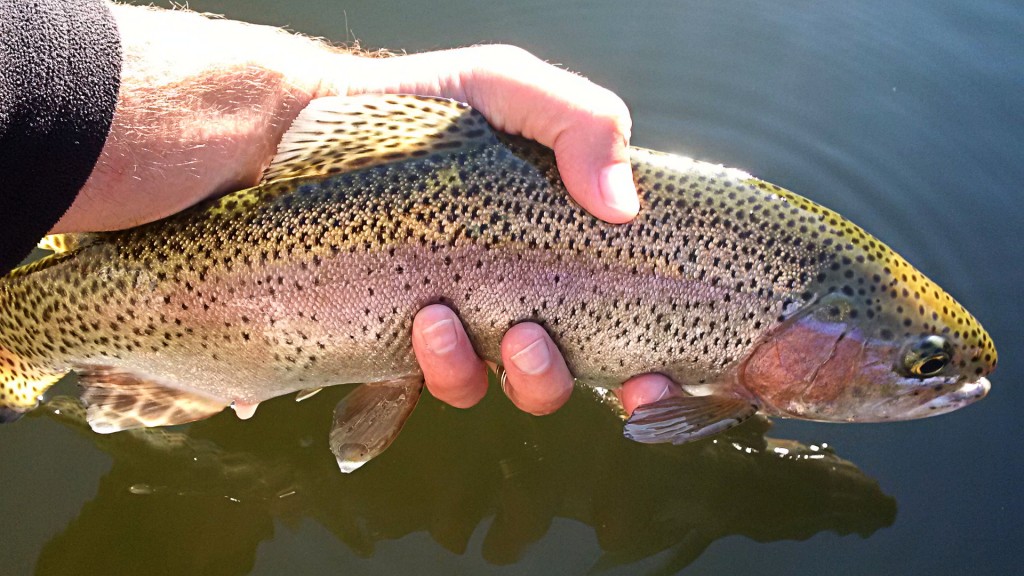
[35,381,896,574]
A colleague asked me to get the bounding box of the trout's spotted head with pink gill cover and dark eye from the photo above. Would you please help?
[739,184,996,422]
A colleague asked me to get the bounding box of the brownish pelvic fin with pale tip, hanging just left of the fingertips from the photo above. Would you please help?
[330,376,423,474]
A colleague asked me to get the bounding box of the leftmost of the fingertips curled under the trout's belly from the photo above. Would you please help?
[413,304,487,408]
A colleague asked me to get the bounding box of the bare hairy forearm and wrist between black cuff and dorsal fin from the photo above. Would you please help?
[54,4,355,232]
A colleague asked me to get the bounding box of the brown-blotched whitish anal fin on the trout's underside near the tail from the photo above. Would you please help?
[79,370,227,434]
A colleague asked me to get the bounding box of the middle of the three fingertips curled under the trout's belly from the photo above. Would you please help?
[502,323,572,416]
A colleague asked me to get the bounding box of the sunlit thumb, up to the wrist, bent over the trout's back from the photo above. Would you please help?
[347,45,640,223]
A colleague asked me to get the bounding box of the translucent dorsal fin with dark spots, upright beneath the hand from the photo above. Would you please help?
[263,94,497,182]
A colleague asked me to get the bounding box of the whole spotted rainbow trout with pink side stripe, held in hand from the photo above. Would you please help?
[0,95,996,471]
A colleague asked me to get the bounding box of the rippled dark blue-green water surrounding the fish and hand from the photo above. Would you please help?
[0,0,1024,575]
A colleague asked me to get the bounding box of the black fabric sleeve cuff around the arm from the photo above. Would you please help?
[0,0,121,274]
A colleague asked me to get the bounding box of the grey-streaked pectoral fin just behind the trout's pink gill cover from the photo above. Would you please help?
[625,396,758,444]
